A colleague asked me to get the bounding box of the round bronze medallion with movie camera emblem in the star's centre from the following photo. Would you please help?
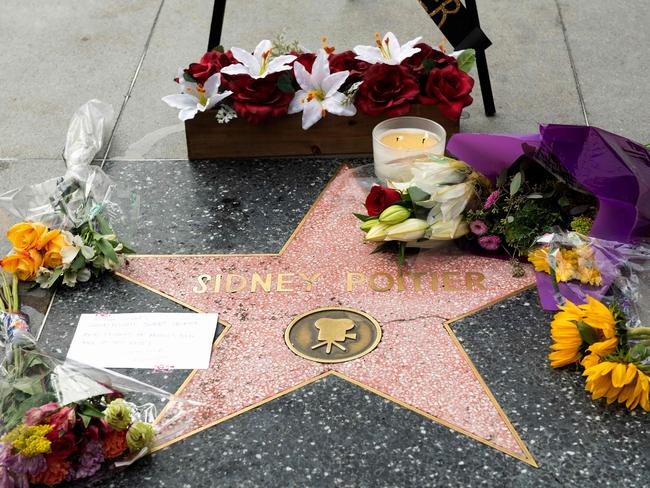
[284,307,381,363]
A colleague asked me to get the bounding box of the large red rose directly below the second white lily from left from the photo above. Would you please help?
[228,72,293,124]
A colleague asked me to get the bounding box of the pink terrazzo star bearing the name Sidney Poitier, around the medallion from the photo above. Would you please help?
[121,168,535,465]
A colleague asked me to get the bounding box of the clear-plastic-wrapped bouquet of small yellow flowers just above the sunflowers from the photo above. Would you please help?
[528,229,650,316]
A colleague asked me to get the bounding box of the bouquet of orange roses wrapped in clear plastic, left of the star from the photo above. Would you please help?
[0,100,139,288]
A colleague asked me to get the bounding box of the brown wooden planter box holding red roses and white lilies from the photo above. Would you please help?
[185,105,459,159]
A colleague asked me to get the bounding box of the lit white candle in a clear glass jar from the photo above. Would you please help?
[372,117,446,181]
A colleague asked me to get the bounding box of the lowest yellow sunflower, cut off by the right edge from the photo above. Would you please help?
[582,361,650,412]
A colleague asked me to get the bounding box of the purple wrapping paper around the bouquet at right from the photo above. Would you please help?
[447,124,650,310]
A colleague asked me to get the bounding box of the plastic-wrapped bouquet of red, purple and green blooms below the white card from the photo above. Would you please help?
[0,311,199,487]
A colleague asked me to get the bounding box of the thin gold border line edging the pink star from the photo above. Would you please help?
[96,163,539,468]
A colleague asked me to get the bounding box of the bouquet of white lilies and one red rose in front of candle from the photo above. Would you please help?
[355,156,487,265]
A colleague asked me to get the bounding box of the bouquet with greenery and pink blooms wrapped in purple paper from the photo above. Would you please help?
[448,125,650,310]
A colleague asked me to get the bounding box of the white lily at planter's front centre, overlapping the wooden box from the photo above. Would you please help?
[289,49,357,129]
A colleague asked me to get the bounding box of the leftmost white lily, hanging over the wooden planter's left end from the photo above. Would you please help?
[162,69,232,121]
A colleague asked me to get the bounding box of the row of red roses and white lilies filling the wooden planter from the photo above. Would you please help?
[163,32,474,129]
